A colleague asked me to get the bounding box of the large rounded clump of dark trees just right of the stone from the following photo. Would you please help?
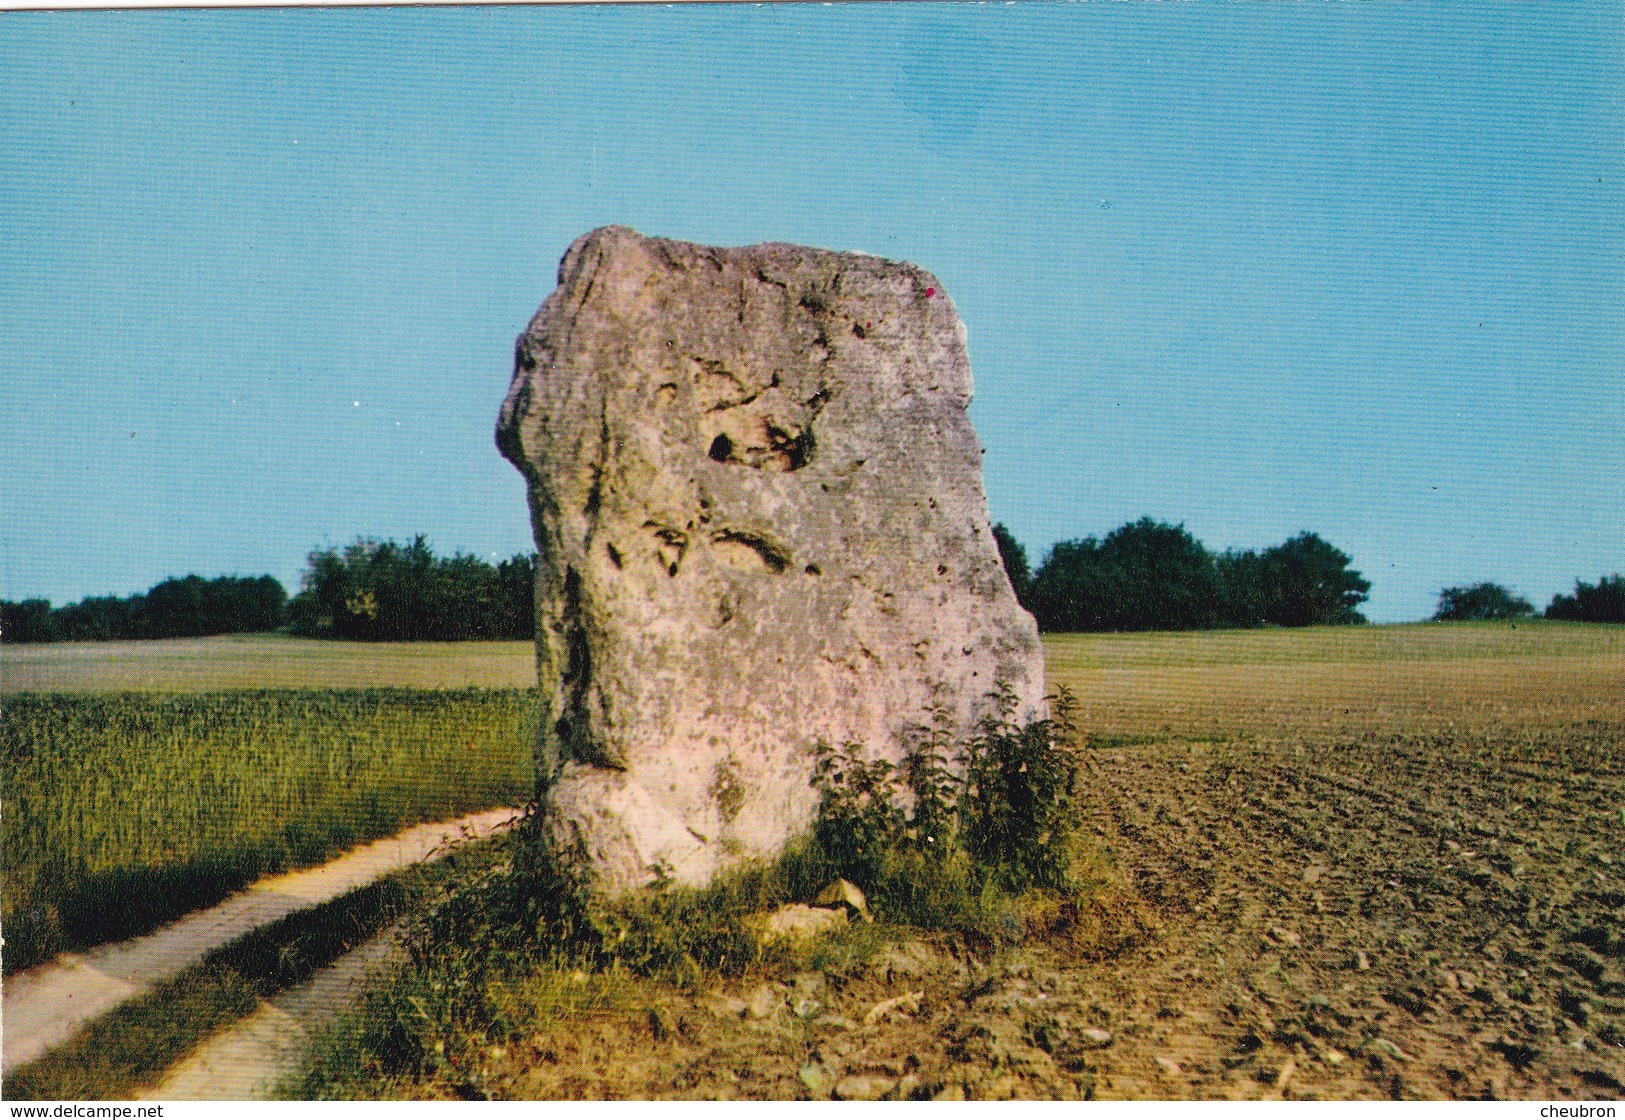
[1012,517,1372,632]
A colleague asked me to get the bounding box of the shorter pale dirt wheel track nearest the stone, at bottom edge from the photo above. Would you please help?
[143,928,397,1100]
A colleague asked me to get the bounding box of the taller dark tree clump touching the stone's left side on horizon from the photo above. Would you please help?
[289,535,536,642]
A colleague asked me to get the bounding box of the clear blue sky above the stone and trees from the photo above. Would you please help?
[0,2,1625,621]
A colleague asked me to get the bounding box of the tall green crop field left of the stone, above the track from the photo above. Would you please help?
[0,689,536,972]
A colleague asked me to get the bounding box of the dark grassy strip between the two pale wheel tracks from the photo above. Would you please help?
[3,844,491,1100]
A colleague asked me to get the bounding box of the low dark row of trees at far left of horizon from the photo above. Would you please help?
[0,575,288,644]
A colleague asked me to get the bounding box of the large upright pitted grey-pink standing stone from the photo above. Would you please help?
[497,226,1043,889]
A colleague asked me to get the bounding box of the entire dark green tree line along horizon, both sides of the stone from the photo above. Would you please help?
[0,529,1625,644]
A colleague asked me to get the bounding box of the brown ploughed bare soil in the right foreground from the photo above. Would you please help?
[432,743,1625,1099]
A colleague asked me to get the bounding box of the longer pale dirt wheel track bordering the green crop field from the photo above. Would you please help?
[0,810,517,1070]
